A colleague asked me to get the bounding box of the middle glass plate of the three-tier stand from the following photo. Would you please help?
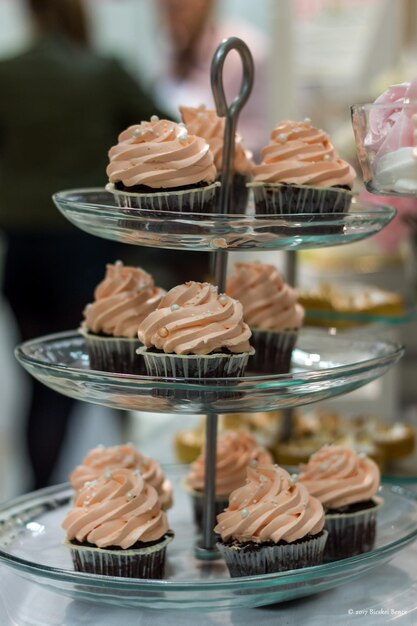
[16,328,403,414]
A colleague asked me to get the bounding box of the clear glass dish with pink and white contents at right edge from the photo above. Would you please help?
[351,101,417,198]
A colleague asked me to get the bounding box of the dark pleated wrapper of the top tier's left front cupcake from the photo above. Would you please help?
[106,182,220,217]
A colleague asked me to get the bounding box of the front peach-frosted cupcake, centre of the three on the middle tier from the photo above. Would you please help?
[138,281,253,379]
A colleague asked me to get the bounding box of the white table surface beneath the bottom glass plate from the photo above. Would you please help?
[0,542,417,626]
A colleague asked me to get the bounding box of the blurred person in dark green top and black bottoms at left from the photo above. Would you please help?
[0,0,171,488]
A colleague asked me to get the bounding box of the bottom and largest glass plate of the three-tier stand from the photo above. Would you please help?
[0,467,417,610]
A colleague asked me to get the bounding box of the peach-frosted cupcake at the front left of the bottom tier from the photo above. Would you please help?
[62,468,173,578]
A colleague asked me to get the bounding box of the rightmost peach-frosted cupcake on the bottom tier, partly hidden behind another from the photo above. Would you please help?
[299,445,382,561]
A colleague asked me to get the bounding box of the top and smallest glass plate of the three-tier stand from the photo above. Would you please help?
[53,189,395,251]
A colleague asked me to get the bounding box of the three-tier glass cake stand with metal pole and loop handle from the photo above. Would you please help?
[0,38,417,610]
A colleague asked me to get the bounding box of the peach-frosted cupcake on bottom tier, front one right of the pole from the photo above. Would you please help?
[214,458,327,577]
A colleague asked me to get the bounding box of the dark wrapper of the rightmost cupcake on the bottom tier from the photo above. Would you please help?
[324,498,383,562]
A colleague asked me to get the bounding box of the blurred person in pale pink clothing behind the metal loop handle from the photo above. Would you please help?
[155,0,269,153]
